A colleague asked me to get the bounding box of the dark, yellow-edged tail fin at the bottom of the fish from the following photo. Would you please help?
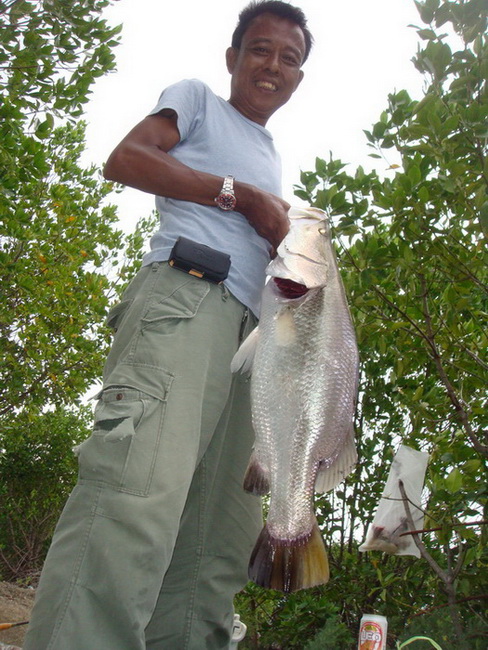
[249,521,329,593]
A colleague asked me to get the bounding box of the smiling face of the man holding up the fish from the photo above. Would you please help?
[226,14,305,126]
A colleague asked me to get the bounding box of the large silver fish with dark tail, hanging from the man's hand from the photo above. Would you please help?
[232,208,358,592]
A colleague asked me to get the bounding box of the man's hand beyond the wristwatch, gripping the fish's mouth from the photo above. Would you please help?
[234,181,290,251]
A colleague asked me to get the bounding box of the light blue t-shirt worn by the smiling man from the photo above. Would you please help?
[143,79,281,315]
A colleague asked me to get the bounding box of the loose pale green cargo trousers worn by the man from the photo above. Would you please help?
[24,263,261,650]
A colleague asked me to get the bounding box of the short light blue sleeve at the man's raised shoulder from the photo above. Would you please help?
[149,79,205,140]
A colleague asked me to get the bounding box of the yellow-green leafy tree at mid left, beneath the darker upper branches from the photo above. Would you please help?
[0,125,122,416]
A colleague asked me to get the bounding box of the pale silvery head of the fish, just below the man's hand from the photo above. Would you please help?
[266,208,330,290]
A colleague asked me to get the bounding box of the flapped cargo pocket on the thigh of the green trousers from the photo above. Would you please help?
[77,378,169,496]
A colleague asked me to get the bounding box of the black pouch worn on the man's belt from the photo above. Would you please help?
[169,237,230,284]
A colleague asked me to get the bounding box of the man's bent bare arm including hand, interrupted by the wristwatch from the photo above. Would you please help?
[104,111,290,248]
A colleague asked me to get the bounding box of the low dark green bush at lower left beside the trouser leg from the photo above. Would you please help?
[0,407,91,580]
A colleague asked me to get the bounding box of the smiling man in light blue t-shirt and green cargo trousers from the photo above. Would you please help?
[25,1,311,650]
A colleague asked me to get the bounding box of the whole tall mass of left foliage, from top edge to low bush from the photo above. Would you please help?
[0,0,126,417]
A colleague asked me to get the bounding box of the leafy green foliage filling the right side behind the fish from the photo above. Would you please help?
[238,0,488,650]
